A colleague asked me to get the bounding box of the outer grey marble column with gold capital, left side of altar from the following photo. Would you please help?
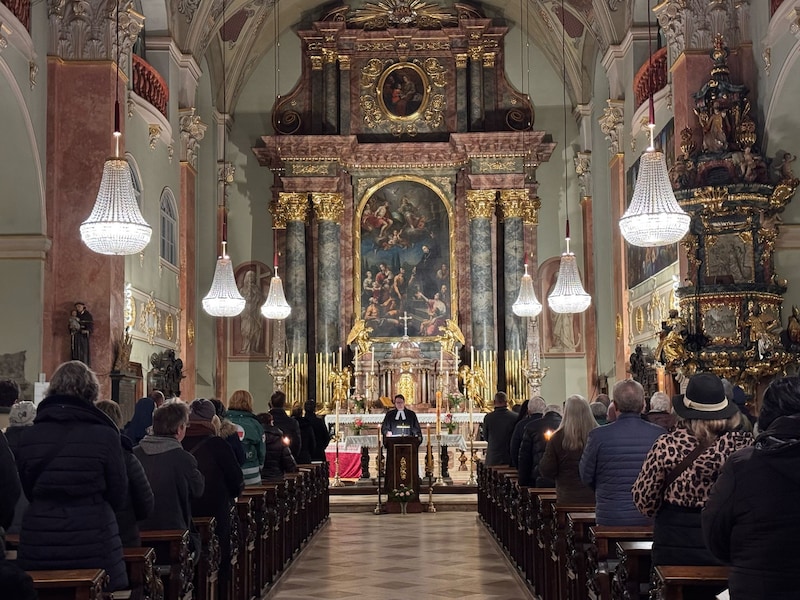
[278,192,308,354]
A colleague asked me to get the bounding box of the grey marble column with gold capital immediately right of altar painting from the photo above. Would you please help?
[467,190,497,351]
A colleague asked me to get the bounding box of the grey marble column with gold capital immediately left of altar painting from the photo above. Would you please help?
[311,192,344,354]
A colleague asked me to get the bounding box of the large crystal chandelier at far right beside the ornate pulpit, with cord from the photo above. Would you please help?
[619,0,691,247]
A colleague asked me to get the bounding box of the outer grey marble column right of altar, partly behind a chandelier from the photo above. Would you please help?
[500,189,528,352]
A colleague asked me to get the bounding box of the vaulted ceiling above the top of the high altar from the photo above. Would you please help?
[141,0,634,112]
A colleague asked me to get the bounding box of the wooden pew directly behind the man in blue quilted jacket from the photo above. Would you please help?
[586,525,653,600]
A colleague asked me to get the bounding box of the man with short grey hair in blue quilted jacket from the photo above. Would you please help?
[580,379,664,527]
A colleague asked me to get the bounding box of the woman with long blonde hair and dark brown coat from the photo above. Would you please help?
[539,394,598,506]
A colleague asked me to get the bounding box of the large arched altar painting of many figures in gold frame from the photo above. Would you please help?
[356,176,455,338]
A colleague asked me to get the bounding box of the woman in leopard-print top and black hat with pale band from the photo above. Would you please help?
[633,373,752,576]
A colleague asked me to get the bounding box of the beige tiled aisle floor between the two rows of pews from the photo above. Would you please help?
[267,512,532,600]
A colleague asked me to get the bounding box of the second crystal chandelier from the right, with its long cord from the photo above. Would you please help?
[547,0,592,314]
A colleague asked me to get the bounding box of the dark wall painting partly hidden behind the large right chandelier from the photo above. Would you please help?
[625,121,678,289]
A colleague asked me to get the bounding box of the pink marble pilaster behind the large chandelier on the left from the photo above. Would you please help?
[42,57,125,398]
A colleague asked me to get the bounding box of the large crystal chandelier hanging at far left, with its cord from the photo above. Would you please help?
[80,4,152,255]
